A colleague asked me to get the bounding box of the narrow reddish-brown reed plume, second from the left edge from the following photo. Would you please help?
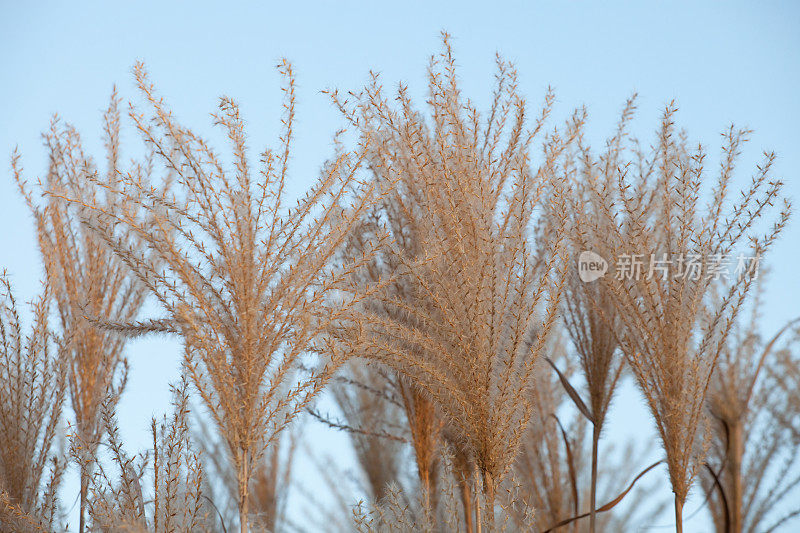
[12,91,149,533]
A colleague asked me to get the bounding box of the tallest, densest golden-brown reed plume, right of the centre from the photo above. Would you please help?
[332,36,574,529]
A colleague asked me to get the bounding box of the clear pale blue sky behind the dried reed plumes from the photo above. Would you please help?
[0,0,800,531]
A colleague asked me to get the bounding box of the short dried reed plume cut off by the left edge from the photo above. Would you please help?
[0,271,66,531]
